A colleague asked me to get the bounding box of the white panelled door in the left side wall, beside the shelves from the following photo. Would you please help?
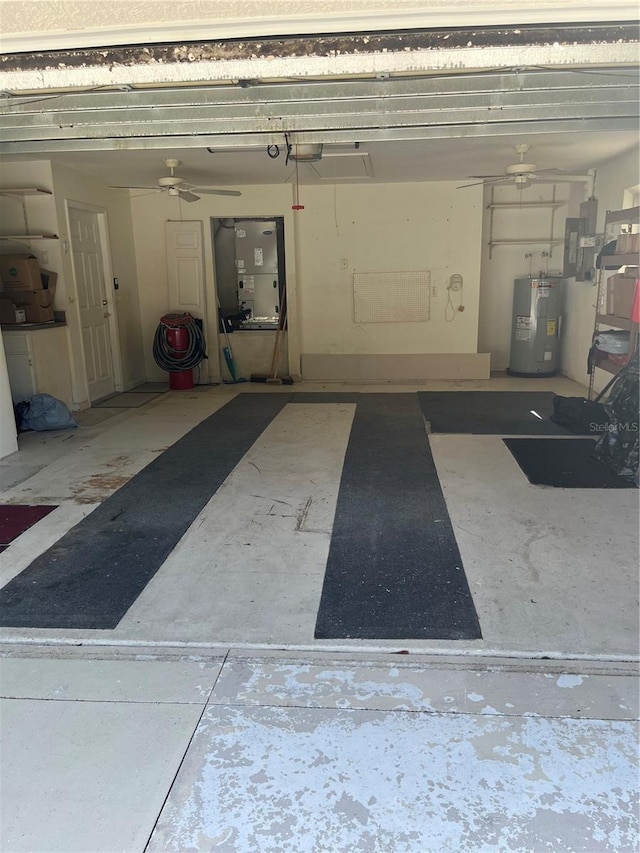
[69,207,115,402]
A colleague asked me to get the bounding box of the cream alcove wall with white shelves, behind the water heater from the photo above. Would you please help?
[478,184,572,371]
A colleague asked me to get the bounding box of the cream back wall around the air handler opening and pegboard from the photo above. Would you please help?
[132,182,482,381]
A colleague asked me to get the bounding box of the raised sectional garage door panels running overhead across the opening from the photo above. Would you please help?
[0,69,640,154]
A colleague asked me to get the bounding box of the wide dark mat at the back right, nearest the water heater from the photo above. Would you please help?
[418,391,571,435]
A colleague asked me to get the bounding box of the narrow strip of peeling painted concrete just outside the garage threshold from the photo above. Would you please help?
[211,654,639,720]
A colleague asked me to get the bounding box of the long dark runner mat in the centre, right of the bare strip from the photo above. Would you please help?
[315,394,481,640]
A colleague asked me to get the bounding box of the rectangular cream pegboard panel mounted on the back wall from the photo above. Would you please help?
[353,270,431,323]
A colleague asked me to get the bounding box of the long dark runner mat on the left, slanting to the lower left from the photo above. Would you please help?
[0,394,289,629]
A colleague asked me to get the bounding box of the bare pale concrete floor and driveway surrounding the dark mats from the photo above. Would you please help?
[0,378,639,853]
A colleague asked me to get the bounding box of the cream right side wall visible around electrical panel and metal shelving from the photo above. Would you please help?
[560,148,640,390]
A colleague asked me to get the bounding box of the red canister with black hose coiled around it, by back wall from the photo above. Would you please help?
[153,314,207,391]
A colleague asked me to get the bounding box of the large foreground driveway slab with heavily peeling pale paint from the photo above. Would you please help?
[147,706,638,853]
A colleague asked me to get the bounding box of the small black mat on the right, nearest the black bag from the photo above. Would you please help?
[504,438,636,489]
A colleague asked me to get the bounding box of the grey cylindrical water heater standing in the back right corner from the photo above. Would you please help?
[507,275,562,376]
